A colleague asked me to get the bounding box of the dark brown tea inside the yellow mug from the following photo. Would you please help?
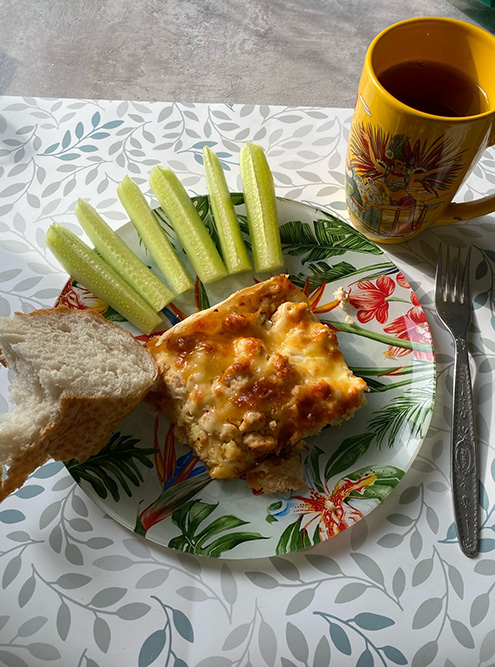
[378,60,495,118]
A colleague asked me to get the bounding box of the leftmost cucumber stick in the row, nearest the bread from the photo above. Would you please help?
[46,222,162,334]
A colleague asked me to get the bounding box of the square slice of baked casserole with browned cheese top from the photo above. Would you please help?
[147,275,367,493]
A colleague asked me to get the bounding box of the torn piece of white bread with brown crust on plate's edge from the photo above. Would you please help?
[0,307,157,501]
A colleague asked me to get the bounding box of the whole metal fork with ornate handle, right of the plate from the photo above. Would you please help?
[435,246,479,556]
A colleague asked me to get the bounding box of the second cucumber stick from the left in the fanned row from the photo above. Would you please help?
[75,199,174,312]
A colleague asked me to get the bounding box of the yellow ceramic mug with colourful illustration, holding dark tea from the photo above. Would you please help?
[346,17,495,243]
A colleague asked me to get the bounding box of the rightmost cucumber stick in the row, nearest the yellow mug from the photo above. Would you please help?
[240,142,284,271]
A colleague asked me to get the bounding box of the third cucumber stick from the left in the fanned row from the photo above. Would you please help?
[117,176,194,294]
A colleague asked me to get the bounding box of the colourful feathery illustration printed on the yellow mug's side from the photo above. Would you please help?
[346,123,464,236]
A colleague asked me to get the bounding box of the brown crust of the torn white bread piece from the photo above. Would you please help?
[0,306,157,502]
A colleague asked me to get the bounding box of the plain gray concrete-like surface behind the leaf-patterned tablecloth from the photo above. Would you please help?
[0,0,495,106]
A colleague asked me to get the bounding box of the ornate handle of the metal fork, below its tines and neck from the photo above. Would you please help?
[452,338,479,556]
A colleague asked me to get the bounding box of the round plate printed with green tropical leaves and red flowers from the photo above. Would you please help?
[63,193,435,559]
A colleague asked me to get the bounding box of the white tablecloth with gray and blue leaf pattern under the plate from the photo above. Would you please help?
[0,98,495,667]
